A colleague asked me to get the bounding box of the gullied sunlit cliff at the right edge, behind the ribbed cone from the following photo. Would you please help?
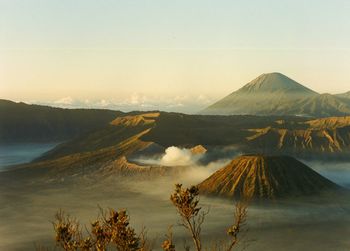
[246,117,350,157]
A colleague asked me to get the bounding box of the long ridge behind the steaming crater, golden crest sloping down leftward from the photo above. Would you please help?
[6,112,282,176]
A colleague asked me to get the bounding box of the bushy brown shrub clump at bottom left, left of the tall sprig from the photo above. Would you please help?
[53,209,146,251]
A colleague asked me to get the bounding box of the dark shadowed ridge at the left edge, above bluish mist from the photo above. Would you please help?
[0,99,124,143]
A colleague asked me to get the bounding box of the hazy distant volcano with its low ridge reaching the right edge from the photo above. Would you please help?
[200,73,350,117]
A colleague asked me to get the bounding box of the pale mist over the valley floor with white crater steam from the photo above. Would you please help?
[0,147,350,251]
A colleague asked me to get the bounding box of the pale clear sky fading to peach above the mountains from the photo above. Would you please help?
[0,0,350,113]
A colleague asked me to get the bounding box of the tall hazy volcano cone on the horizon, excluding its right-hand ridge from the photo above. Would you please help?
[202,73,317,115]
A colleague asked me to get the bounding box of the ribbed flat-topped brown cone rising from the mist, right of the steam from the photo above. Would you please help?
[199,155,338,199]
